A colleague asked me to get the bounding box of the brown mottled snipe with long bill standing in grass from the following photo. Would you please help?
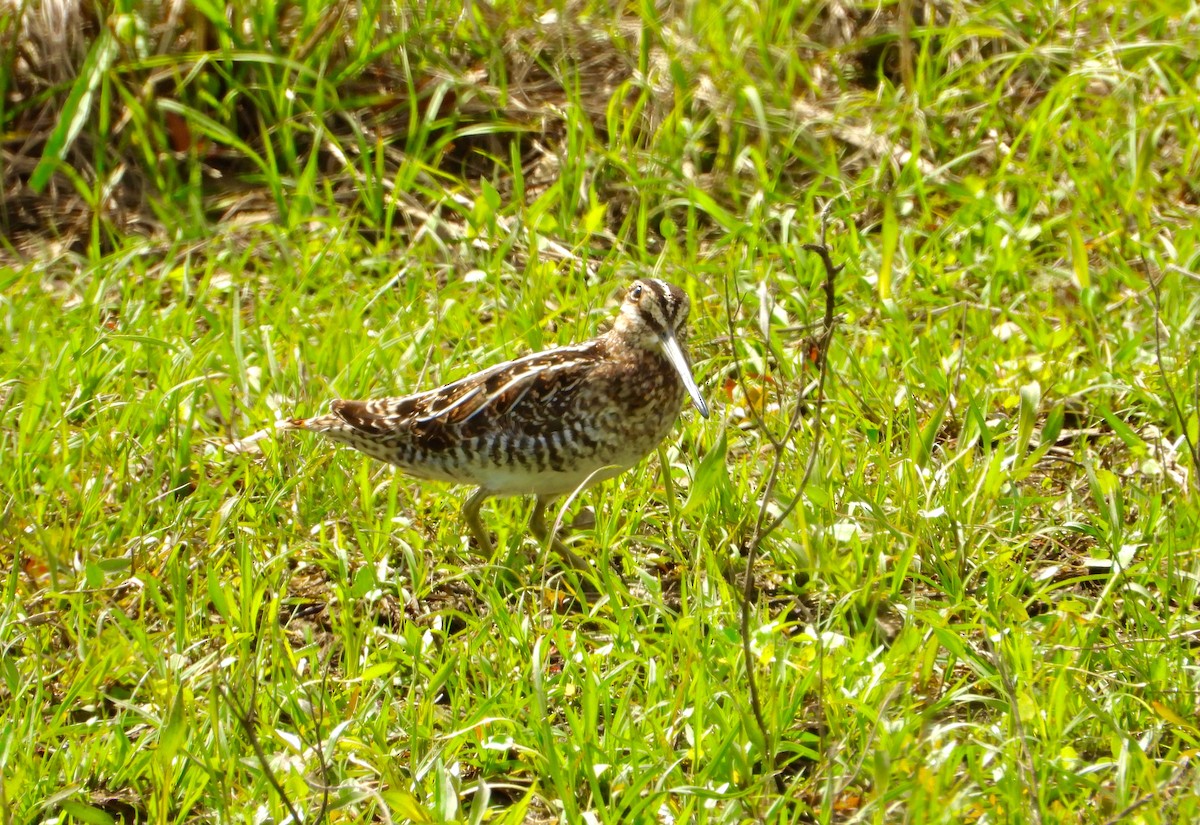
[276,278,709,570]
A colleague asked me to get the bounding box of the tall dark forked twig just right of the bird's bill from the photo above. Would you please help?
[726,206,841,794]
